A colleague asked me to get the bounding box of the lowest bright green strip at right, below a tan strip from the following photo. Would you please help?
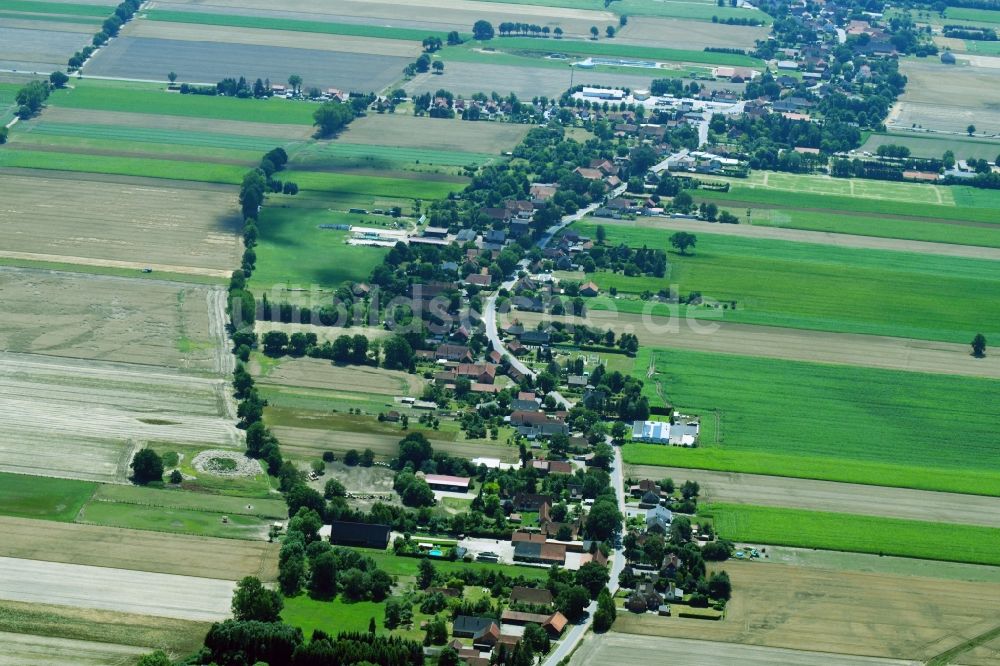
[699,504,1000,566]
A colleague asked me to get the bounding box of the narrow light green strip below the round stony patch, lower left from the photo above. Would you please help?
[77,501,268,540]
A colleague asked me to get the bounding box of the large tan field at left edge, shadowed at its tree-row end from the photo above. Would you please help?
[0,174,243,277]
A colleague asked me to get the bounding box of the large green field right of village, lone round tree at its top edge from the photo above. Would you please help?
[578,223,1000,344]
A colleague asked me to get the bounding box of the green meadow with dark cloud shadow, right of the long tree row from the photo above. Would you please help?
[251,205,388,289]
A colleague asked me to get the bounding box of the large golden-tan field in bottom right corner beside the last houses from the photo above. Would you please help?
[615,562,1000,662]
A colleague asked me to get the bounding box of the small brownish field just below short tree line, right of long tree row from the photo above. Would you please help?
[258,358,424,396]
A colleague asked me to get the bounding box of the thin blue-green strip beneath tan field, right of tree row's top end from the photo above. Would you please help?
[293,141,498,170]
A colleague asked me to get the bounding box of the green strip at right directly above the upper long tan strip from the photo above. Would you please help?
[694,185,1000,224]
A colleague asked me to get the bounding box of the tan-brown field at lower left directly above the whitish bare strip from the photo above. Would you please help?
[0,517,278,581]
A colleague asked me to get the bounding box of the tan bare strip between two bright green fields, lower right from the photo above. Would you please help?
[625,465,1000,528]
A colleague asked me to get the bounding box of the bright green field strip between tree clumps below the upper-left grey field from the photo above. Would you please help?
[48,79,318,125]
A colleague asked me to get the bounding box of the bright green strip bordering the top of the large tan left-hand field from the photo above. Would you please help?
[0,148,247,185]
